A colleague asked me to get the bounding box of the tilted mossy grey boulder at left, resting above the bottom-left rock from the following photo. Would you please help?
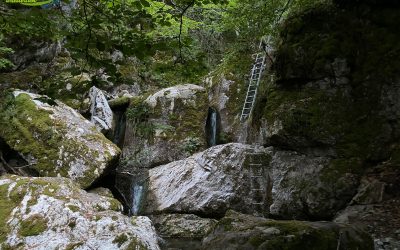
[0,91,120,188]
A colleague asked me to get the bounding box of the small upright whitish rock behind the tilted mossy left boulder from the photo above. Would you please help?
[89,87,113,132]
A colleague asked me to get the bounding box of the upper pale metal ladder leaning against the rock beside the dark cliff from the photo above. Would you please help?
[240,53,266,122]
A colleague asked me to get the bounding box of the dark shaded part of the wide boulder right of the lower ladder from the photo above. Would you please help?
[268,148,359,220]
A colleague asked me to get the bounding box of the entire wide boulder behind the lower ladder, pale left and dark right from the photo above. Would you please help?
[145,143,359,219]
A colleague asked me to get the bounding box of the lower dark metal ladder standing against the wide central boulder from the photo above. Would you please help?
[249,152,267,212]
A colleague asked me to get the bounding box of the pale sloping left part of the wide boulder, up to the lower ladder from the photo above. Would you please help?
[145,143,268,216]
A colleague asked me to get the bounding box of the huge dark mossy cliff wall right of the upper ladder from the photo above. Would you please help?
[255,1,400,166]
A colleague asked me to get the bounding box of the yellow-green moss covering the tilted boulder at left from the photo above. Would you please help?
[0,93,118,187]
